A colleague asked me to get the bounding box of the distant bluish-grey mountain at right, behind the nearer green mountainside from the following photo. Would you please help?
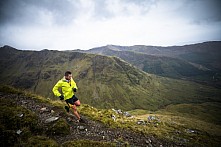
[84,41,221,87]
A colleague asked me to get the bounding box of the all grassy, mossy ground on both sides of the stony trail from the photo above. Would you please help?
[0,87,221,146]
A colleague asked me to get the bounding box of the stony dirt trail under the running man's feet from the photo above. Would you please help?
[0,93,183,147]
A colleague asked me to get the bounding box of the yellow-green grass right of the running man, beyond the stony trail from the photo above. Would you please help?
[80,99,221,146]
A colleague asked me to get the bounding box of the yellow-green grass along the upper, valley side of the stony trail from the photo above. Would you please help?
[0,86,221,146]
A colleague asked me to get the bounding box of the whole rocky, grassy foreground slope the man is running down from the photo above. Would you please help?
[0,86,221,147]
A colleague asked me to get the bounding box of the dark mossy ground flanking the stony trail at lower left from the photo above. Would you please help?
[0,86,70,146]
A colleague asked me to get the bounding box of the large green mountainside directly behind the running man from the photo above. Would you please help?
[0,46,221,110]
